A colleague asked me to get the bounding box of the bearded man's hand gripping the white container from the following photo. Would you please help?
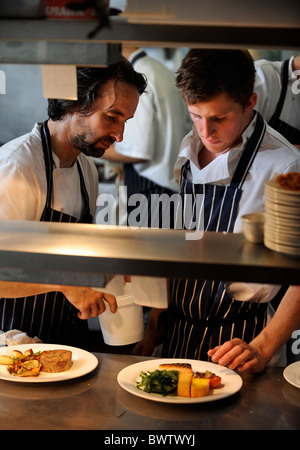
[59,286,117,320]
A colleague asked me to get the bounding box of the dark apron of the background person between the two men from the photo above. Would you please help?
[123,51,175,228]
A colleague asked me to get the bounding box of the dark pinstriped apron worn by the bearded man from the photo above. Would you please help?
[0,122,93,349]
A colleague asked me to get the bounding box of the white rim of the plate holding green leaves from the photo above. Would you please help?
[117,358,243,405]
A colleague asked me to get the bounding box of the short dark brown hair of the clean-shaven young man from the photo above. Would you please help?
[176,49,255,107]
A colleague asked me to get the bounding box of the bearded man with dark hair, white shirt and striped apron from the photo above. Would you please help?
[0,59,146,347]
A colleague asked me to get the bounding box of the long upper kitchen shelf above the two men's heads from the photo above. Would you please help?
[0,13,300,51]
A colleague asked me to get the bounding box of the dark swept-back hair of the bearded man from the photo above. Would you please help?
[48,57,147,121]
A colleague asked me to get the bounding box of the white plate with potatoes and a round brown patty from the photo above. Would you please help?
[0,344,98,383]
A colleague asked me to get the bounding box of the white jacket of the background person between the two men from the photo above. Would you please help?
[114,50,191,191]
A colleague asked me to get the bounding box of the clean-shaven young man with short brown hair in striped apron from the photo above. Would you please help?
[135,49,300,370]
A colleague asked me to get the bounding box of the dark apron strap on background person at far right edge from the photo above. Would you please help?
[268,59,300,145]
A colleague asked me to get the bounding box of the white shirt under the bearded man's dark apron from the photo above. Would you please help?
[0,124,98,220]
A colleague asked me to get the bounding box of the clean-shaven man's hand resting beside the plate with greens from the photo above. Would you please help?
[207,338,267,373]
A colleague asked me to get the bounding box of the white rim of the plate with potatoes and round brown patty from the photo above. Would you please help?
[0,343,99,383]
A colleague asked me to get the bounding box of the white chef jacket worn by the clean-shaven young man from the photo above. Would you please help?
[175,116,300,302]
